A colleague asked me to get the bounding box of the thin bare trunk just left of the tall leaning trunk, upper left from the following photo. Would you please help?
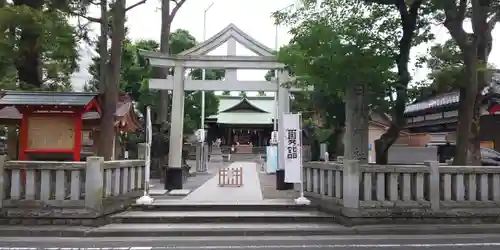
[99,0,109,94]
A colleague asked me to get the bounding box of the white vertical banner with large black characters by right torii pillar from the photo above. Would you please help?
[281,113,302,183]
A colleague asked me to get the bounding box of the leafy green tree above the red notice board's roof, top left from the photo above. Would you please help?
[0,0,85,90]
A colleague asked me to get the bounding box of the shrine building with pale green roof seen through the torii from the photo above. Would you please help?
[205,95,276,153]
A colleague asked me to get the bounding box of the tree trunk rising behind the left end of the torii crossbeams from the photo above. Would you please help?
[156,0,172,124]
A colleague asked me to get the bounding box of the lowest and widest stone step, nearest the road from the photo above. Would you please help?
[86,223,355,237]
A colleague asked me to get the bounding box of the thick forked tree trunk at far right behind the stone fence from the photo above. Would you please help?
[431,0,500,165]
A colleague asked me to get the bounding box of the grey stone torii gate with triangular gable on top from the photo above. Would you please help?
[140,24,302,189]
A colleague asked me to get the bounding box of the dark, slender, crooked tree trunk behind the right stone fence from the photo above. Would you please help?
[375,0,423,165]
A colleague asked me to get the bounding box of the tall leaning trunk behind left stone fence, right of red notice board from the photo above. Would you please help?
[99,0,126,160]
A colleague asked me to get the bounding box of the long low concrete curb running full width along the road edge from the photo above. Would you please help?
[0,224,500,237]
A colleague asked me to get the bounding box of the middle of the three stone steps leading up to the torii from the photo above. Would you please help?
[111,210,333,224]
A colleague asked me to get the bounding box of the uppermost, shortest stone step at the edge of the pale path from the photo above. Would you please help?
[131,199,317,211]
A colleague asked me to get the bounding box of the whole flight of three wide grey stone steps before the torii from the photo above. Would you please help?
[87,200,344,237]
